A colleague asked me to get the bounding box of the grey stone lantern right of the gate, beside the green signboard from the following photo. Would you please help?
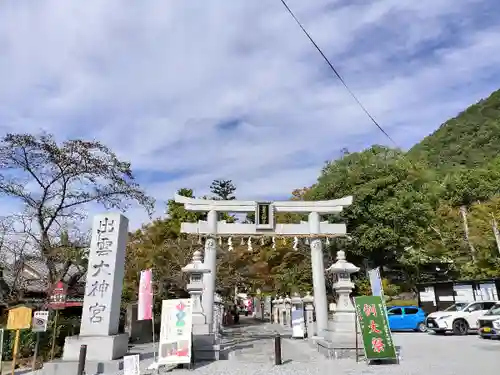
[326,250,359,341]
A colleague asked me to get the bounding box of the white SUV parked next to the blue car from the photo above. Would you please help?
[425,301,498,335]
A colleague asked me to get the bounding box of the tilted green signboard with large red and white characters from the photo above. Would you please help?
[354,296,397,361]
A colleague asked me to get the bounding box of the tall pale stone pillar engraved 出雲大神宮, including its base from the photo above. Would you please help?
[63,213,128,360]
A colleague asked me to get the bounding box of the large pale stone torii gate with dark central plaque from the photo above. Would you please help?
[175,194,352,336]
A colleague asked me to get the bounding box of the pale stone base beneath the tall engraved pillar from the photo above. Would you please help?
[62,333,128,361]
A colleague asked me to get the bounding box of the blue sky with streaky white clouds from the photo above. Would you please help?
[0,0,500,231]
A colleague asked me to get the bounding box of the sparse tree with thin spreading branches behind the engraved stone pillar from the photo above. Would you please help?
[0,134,154,283]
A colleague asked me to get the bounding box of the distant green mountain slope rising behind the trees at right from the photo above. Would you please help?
[408,90,500,170]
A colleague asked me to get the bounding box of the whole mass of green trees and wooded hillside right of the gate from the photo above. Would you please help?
[306,91,500,281]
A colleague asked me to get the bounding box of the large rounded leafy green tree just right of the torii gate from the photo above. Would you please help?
[306,146,440,266]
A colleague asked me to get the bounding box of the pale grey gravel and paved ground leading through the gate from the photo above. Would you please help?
[28,319,500,375]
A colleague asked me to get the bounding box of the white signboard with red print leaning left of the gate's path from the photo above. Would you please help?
[158,299,193,365]
